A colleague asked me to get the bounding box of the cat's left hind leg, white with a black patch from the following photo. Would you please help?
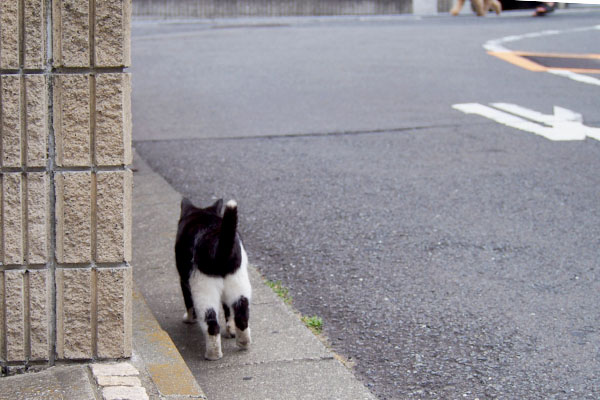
[190,272,223,361]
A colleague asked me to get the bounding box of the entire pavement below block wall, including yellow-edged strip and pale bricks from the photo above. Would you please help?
[0,152,375,400]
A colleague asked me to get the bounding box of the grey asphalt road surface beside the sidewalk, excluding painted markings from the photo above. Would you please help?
[132,10,600,399]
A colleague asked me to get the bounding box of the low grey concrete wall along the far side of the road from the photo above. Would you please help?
[133,0,412,18]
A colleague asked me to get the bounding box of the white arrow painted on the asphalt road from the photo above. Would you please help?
[452,103,600,141]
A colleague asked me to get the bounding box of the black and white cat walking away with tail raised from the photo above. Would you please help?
[175,198,252,360]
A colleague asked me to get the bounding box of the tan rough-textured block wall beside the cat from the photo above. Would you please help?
[0,0,132,373]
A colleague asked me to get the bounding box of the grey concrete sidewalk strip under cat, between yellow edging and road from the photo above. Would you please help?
[133,151,375,400]
